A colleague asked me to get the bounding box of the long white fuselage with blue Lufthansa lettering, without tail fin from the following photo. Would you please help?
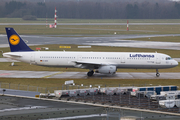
[3,51,178,69]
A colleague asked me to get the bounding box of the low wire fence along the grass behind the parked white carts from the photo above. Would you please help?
[0,82,160,93]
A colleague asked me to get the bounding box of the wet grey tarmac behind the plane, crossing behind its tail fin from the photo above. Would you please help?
[0,34,180,50]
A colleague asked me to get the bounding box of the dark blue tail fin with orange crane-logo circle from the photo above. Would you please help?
[5,27,33,52]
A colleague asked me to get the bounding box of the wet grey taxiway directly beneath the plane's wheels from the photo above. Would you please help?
[0,70,180,79]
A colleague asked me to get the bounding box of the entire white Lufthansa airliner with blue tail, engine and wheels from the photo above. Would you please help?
[3,28,178,77]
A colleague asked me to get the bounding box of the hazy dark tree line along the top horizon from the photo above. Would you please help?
[0,0,180,19]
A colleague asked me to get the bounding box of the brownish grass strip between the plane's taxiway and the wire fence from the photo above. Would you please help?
[0,78,180,88]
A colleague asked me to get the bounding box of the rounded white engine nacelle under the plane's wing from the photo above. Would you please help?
[96,66,116,74]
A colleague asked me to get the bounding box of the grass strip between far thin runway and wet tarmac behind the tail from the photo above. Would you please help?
[0,25,180,37]
